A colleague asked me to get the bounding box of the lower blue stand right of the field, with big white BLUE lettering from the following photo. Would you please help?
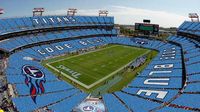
[104,38,188,112]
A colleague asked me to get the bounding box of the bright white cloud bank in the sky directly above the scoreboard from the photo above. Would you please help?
[110,6,187,27]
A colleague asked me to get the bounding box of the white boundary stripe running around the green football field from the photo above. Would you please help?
[46,45,150,89]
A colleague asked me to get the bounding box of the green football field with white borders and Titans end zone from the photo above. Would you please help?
[46,45,149,89]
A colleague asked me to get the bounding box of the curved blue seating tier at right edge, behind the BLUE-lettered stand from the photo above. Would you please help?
[168,36,200,108]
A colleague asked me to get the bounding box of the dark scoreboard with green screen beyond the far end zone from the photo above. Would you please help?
[135,23,159,34]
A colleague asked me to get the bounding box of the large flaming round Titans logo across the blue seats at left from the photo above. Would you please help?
[22,65,46,103]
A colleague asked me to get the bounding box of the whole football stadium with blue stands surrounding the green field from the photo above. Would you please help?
[0,0,200,112]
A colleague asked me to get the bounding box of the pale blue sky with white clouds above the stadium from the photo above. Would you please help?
[0,0,200,27]
